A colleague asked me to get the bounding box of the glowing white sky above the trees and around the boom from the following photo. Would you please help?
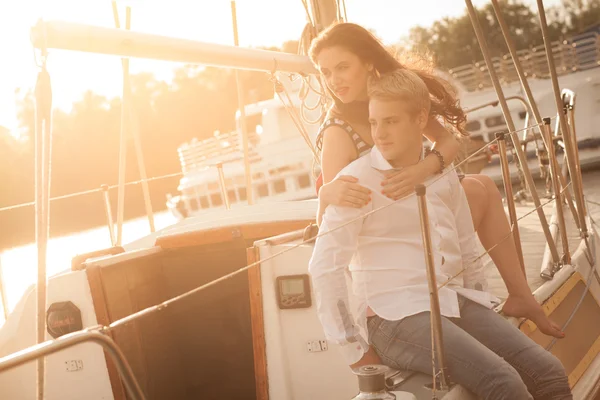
[0,0,559,136]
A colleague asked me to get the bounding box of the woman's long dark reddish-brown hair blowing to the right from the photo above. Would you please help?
[309,22,468,136]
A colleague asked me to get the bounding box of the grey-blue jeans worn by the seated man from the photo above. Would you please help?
[368,296,573,400]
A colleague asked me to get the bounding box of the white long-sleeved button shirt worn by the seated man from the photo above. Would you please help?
[309,147,498,364]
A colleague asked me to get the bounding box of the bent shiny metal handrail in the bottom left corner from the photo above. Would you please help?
[0,326,146,400]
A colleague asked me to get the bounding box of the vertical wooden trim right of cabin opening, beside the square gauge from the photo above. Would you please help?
[248,247,269,400]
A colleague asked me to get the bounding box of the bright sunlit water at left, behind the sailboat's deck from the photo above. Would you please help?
[0,211,177,325]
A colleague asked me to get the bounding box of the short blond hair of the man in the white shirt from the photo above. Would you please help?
[368,68,431,115]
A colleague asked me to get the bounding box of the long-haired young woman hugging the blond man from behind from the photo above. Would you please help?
[310,23,564,338]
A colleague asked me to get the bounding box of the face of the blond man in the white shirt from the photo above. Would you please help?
[369,98,427,167]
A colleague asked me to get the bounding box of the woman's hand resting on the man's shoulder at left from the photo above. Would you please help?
[319,175,371,208]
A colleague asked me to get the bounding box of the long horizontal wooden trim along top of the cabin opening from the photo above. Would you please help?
[156,220,314,249]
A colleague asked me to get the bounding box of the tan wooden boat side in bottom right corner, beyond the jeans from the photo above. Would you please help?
[521,272,600,387]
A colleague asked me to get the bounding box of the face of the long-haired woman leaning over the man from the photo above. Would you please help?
[317,46,372,103]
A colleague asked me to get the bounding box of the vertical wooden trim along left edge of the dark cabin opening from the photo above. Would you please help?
[86,267,129,400]
